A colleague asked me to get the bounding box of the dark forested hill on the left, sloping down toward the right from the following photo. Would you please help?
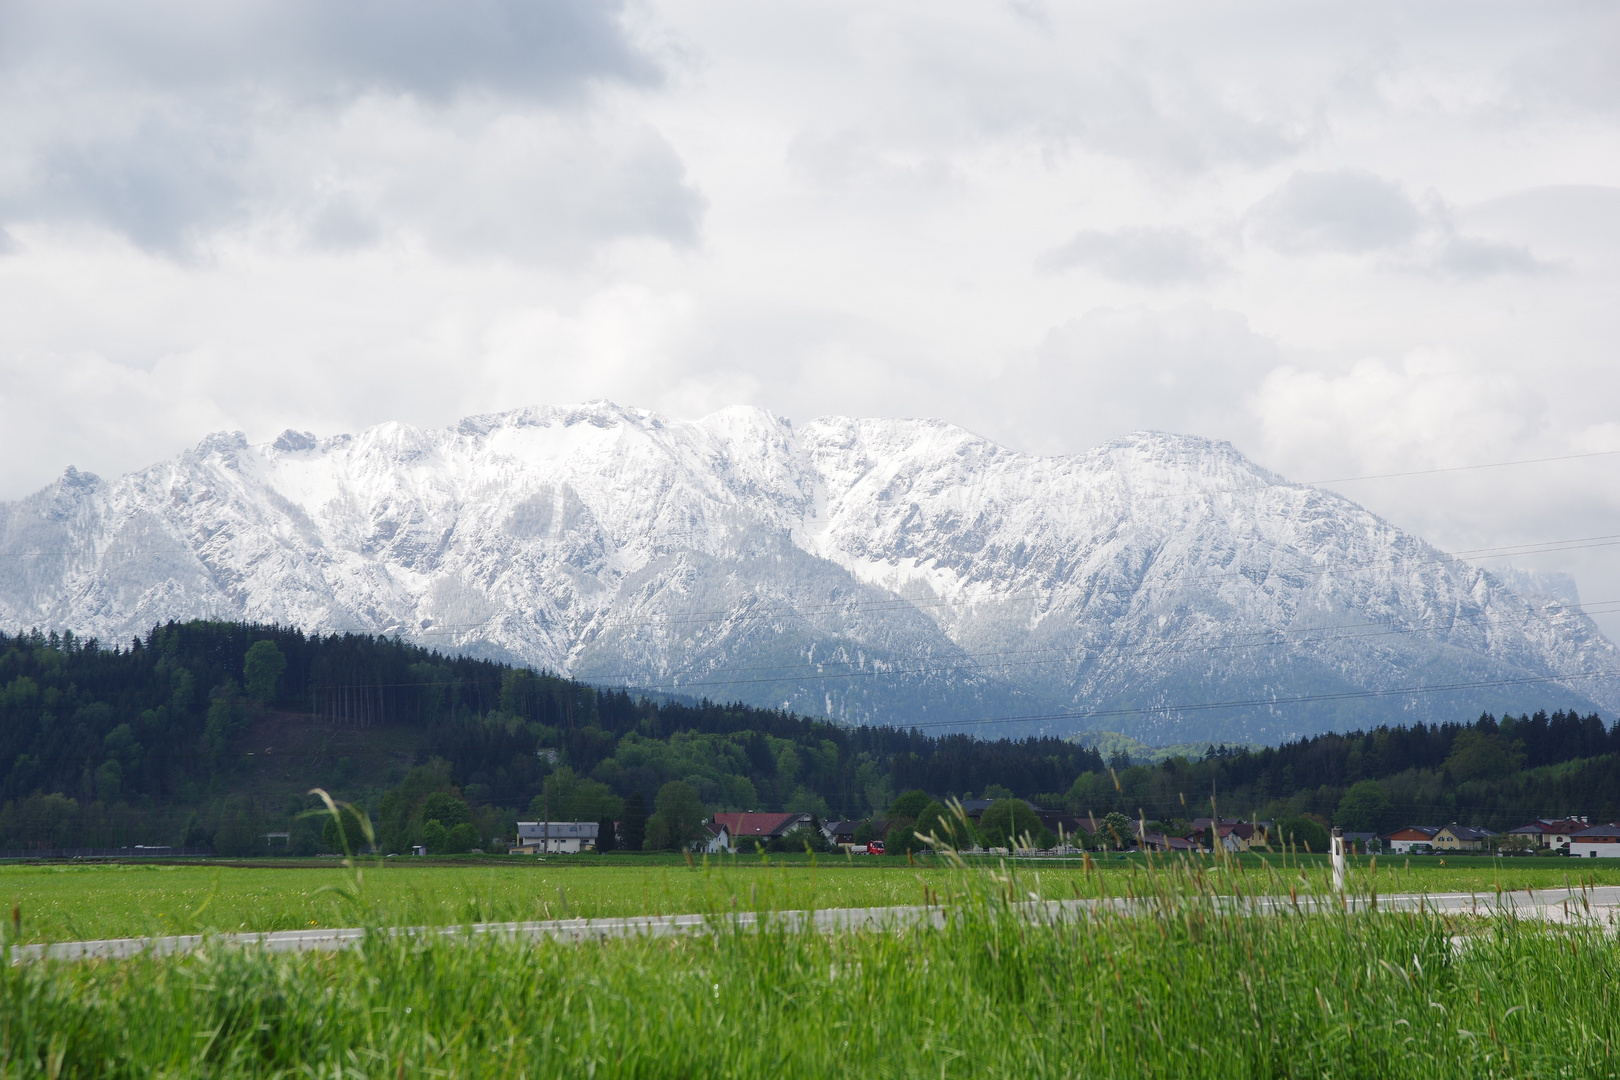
[0,622,1102,848]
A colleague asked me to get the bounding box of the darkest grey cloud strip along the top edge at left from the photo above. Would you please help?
[0,0,659,99]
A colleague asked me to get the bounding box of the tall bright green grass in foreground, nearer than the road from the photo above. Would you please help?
[0,868,1620,1080]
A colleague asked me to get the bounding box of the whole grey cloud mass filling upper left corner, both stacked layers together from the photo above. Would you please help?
[0,0,701,262]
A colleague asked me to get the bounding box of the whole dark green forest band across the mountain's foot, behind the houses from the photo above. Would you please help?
[0,622,1620,855]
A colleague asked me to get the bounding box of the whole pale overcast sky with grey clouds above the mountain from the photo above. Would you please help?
[9,0,1620,633]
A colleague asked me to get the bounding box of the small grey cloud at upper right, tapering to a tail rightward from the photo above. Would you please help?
[1244,168,1549,277]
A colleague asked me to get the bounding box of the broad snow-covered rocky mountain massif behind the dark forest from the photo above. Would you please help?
[0,403,1620,742]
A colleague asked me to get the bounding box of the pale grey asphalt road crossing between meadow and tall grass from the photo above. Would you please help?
[8,886,1620,963]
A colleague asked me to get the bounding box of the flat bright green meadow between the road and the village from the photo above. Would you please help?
[0,855,1620,942]
